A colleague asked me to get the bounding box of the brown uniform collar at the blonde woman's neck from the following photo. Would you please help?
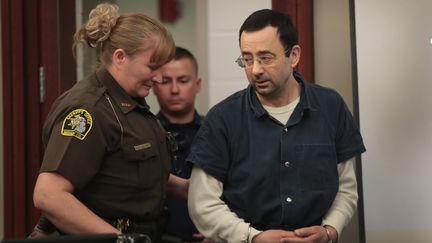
[96,68,150,114]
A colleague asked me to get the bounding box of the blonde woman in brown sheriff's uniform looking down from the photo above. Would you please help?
[34,4,187,242]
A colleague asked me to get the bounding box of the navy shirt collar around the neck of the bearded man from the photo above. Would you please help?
[247,71,312,117]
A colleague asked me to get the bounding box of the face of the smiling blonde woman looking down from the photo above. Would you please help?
[109,37,162,98]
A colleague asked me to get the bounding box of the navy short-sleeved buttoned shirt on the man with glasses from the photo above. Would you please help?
[187,73,365,230]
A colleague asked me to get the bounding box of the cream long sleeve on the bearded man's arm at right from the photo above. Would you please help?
[322,158,358,236]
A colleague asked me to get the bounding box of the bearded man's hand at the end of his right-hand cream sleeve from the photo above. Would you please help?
[279,226,328,243]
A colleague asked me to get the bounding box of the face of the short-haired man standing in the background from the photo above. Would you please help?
[153,58,201,123]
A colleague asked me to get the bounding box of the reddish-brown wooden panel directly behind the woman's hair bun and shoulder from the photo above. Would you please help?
[39,0,77,121]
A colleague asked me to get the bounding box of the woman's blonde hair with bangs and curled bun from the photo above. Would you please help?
[72,3,175,68]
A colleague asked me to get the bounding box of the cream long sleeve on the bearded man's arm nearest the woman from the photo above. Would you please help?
[188,166,261,242]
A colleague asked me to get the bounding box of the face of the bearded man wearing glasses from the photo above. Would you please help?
[240,26,300,107]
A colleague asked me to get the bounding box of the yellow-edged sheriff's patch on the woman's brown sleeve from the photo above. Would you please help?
[61,109,93,140]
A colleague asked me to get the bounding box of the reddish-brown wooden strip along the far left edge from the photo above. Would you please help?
[2,0,26,237]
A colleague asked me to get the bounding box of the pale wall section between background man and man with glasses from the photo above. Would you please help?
[198,0,271,107]
